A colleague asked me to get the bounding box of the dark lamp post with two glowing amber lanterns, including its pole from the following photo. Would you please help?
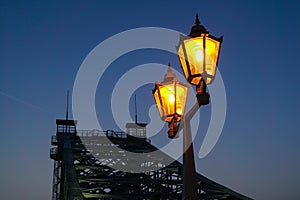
[153,15,223,200]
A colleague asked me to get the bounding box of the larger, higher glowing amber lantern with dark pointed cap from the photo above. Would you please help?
[177,15,223,85]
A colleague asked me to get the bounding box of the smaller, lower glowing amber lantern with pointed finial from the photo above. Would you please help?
[153,64,189,138]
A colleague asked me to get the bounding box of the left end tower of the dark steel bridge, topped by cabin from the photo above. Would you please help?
[50,119,82,200]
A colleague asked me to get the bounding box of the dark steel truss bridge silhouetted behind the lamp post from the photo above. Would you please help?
[50,120,251,200]
